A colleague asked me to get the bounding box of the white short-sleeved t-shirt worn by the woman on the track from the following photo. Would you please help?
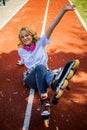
[18,34,50,70]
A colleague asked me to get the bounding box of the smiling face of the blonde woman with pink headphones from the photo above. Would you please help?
[20,30,33,45]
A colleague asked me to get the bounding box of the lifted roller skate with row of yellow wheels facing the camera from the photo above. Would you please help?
[51,60,80,104]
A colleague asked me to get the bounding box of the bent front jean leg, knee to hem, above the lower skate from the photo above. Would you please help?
[35,65,47,94]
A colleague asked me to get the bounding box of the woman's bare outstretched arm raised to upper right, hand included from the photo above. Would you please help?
[45,5,75,38]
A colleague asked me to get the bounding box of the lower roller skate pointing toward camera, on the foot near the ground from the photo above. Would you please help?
[37,97,50,127]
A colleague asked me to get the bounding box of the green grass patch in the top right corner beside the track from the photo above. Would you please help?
[71,0,87,25]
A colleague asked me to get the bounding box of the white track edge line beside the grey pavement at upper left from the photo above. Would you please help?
[0,0,29,30]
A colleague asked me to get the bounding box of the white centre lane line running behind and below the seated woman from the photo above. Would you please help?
[22,0,50,130]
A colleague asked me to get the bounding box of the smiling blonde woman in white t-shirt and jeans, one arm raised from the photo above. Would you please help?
[17,5,79,117]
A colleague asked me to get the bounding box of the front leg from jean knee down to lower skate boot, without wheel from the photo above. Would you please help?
[35,65,50,119]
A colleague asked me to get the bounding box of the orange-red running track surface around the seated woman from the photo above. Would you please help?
[0,0,87,130]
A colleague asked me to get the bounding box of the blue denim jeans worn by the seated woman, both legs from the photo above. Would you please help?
[25,65,54,94]
